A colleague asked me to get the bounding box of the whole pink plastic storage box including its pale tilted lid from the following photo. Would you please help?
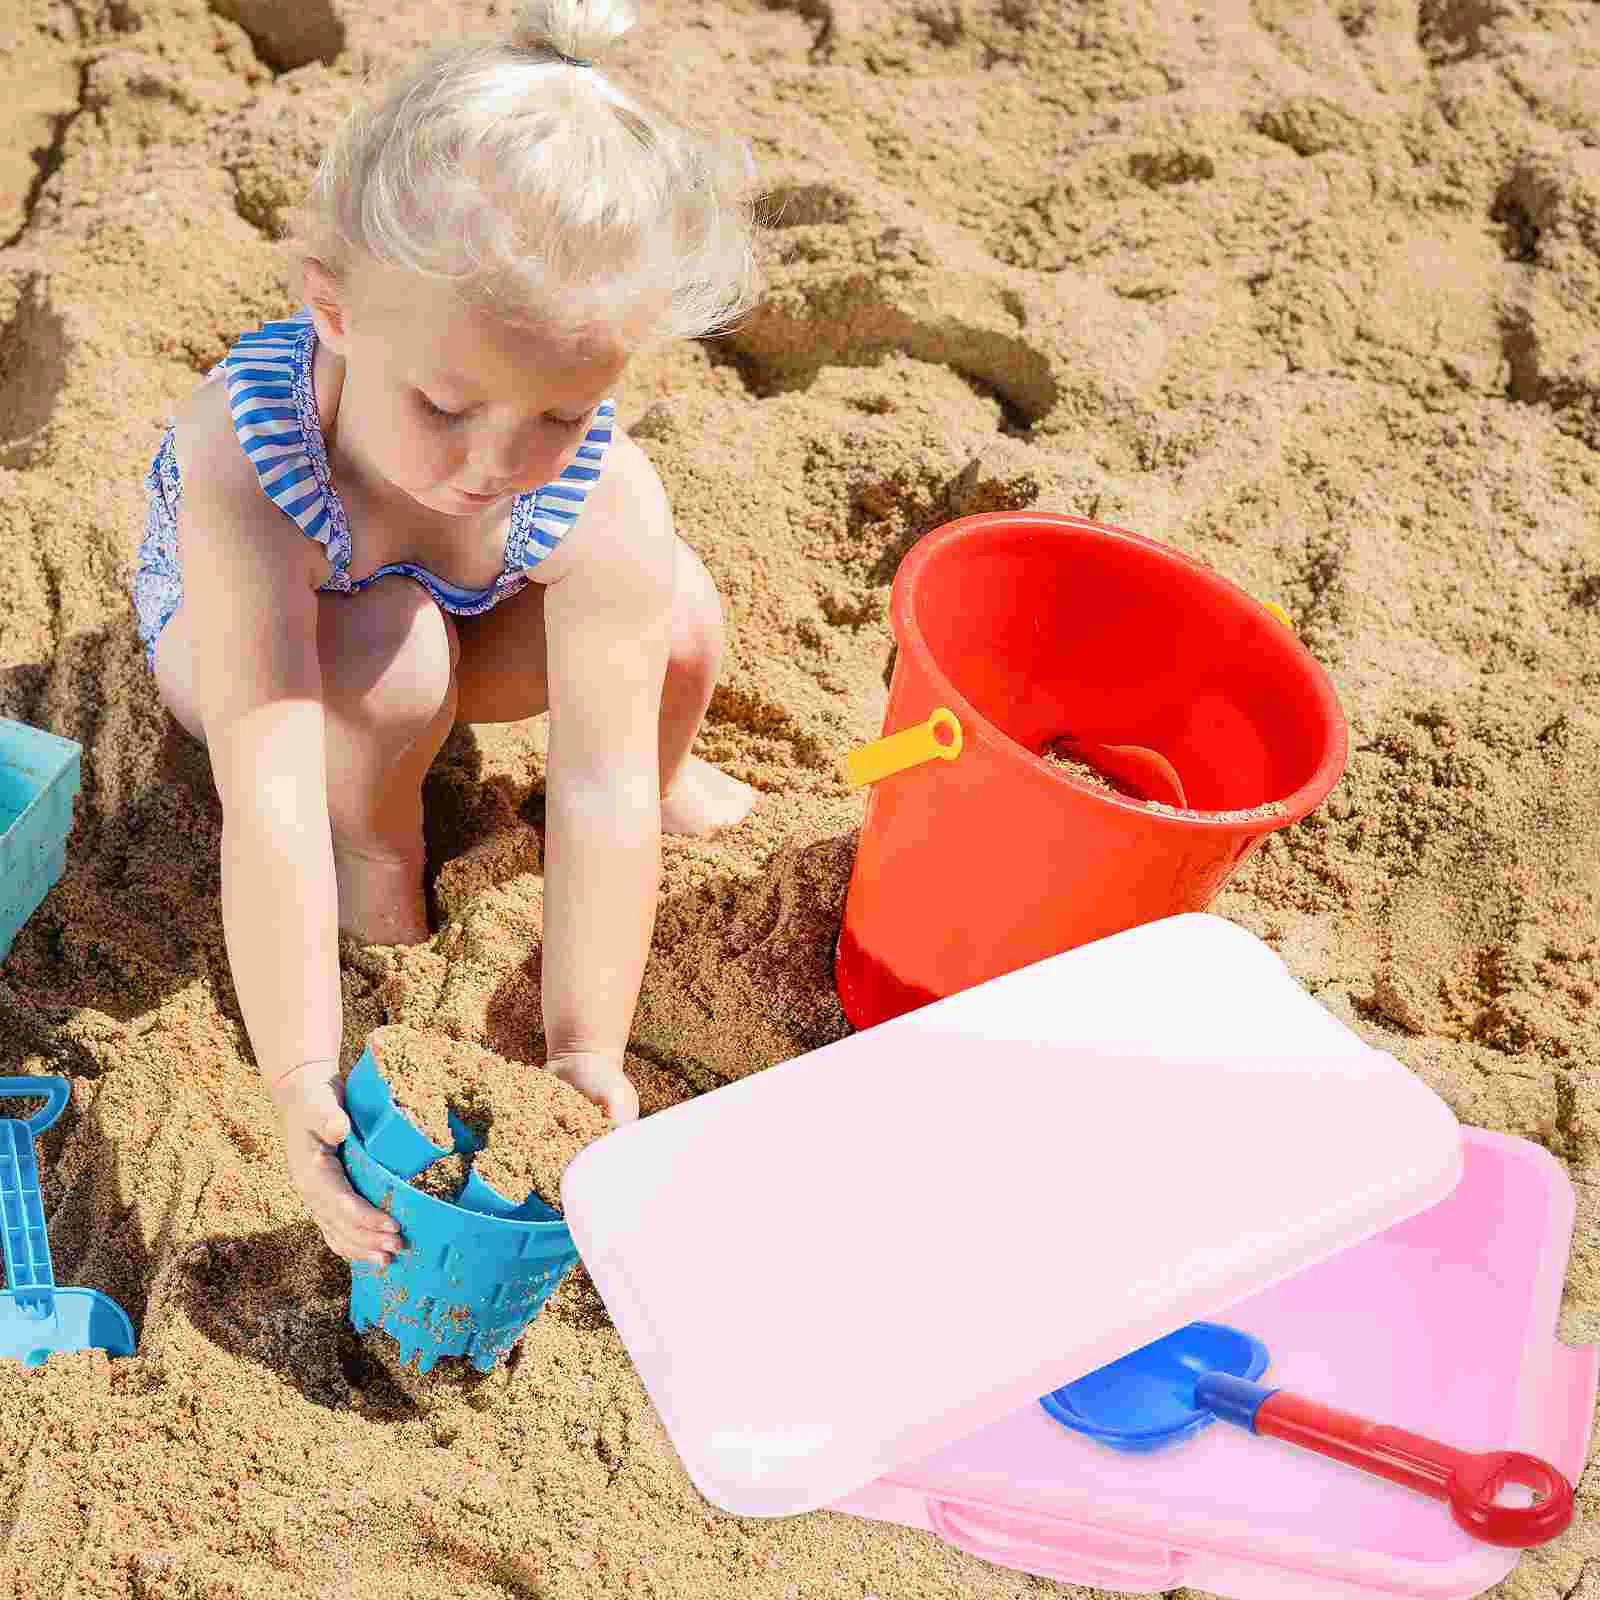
[563,915,1595,1597]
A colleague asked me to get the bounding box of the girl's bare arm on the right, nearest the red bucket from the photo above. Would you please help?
[544,446,675,1120]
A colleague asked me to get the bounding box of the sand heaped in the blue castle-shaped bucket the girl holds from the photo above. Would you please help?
[368,1022,610,1206]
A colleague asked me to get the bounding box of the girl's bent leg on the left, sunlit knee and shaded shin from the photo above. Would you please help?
[155,578,458,944]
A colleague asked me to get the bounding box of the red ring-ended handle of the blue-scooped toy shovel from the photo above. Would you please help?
[1254,1389,1573,1550]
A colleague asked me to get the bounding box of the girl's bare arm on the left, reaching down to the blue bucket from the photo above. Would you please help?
[178,396,400,1259]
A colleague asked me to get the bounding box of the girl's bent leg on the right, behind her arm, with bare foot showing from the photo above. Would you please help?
[458,539,755,834]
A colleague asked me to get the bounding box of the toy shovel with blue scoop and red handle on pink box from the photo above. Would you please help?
[1040,1322,1573,1549]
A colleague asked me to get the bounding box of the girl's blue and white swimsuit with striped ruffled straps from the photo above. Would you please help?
[133,312,616,666]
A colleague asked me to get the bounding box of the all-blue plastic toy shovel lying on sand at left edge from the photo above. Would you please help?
[0,1077,134,1366]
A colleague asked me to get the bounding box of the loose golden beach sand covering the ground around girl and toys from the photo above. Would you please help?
[0,0,1600,1600]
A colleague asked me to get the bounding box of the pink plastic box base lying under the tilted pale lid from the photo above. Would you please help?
[837,1130,1597,1600]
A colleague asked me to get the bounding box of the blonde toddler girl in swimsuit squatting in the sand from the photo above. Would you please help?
[134,0,755,1266]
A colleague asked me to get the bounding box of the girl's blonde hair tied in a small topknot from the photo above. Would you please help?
[291,0,760,347]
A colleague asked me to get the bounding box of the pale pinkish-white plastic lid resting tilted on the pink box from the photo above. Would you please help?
[563,915,1461,1517]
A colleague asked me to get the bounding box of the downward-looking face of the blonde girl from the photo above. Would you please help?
[323,267,627,517]
